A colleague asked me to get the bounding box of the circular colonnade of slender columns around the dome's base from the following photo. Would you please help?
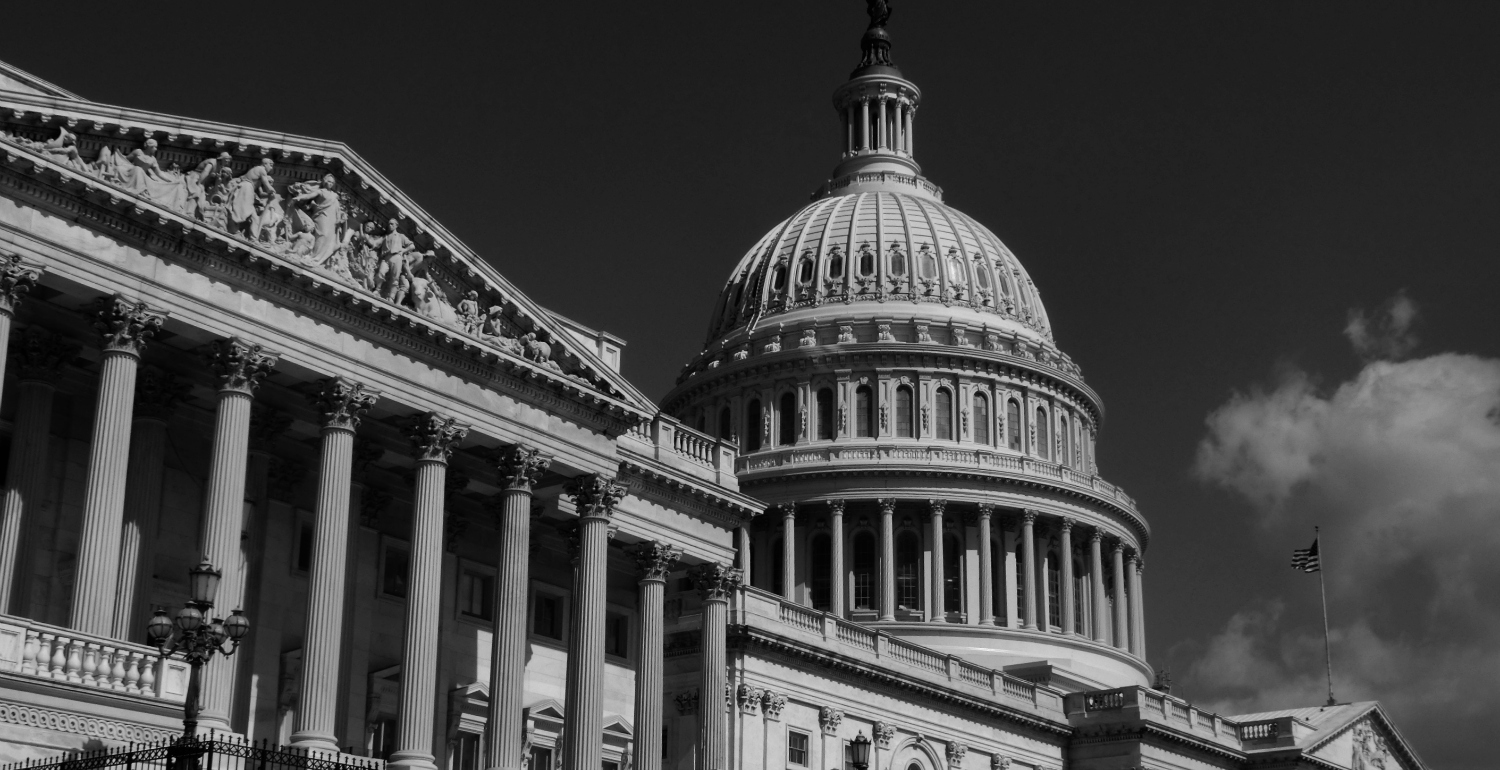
[750,498,1146,659]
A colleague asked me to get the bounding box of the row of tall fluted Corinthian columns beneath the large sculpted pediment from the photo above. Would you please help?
[0,277,740,770]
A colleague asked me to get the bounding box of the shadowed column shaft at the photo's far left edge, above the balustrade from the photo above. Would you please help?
[0,379,54,615]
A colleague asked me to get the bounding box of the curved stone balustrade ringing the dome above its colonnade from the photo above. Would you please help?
[735,441,1140,518]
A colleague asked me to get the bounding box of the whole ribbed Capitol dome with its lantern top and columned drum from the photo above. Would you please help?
[663,13,1152,690]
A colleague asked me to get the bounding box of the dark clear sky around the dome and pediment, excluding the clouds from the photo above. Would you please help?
[0,0,1500,767]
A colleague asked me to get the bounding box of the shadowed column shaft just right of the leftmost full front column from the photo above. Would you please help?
[114,416,168,641]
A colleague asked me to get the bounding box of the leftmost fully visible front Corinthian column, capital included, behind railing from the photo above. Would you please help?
[69,296,167,636]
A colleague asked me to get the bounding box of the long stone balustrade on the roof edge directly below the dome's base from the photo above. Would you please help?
[731,587,1062,720]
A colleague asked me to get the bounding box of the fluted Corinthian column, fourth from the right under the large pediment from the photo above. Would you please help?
[485,444,552,770]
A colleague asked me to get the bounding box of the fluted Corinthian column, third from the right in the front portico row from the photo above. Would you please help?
[563,474,626,770]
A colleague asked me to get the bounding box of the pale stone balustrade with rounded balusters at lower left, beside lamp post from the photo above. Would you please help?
[0,615,188,702]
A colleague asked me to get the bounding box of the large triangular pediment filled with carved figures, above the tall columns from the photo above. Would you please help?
[0,68,656,423]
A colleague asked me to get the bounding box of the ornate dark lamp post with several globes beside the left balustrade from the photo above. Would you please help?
[146,557,251,741]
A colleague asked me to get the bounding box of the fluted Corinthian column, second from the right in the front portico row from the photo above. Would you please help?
[632,543,681,770]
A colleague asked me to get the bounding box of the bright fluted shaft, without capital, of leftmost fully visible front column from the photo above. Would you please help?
[69,350,140,636]
